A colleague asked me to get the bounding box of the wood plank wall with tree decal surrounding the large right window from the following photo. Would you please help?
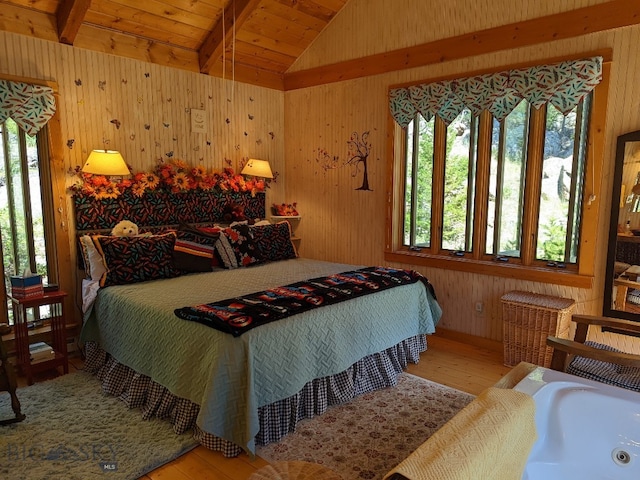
[285,0,640,351]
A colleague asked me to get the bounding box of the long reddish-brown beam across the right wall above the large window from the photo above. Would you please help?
[284,0,640,91]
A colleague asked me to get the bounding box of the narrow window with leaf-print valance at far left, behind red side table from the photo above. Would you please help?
[0,80,58,324]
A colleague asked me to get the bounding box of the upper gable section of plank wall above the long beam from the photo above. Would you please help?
[287,0,609,73]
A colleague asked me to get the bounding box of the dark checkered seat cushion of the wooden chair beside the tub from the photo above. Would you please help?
[567,341,640,392]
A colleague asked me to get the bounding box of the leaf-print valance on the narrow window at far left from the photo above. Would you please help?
[0,80,56,136]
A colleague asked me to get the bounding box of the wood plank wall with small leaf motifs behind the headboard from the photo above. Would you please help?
[0,32,285,326]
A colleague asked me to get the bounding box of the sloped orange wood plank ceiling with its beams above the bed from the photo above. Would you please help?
[0,0,348,90]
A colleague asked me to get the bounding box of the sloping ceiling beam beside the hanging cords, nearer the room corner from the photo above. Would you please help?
[198,0,261,74]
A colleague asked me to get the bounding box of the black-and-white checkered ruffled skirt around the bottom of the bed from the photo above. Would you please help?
[85,335,427,457]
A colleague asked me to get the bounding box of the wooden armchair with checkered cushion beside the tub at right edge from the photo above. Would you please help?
[547,315,640,392]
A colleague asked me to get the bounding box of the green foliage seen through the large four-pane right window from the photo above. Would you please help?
[404,94,586,262]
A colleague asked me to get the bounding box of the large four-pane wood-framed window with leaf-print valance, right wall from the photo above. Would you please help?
[386,60,601,283]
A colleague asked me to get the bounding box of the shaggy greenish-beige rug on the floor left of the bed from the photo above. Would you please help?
[0,372,197,480]
